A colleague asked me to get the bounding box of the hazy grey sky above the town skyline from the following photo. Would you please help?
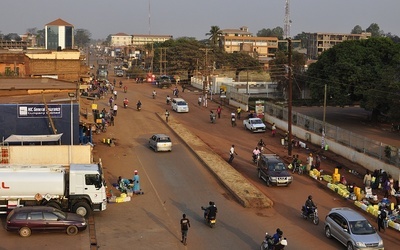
[0,0,400,40]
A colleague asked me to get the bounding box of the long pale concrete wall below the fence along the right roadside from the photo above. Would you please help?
[265,115,400,179]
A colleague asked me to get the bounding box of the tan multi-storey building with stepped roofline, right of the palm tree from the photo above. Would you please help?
[219,26,278,58]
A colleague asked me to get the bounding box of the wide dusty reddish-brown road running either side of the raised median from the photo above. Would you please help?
[0,71,398,249]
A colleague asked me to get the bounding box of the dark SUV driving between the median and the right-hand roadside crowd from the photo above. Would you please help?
[258,154,293,186]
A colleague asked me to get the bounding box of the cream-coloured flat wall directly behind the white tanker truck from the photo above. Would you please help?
[9,145,93,165]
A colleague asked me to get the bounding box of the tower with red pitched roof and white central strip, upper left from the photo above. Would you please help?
[45,18,74,50]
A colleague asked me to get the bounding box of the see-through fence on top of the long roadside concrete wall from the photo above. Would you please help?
[265,103,400,167]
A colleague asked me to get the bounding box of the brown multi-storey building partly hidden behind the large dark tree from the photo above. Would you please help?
[306,32,371,60]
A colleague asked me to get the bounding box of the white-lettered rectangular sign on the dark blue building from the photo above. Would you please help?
[17,104,62,118]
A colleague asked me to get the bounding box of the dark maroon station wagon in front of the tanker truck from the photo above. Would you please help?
[6,206,87,237]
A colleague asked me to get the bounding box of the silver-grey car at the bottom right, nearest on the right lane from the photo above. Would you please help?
[325,207,384,250]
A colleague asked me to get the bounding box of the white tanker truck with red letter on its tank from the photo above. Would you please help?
[0,164,107,217]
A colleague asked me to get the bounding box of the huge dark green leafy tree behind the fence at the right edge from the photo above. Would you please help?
[307,38,400,120]
